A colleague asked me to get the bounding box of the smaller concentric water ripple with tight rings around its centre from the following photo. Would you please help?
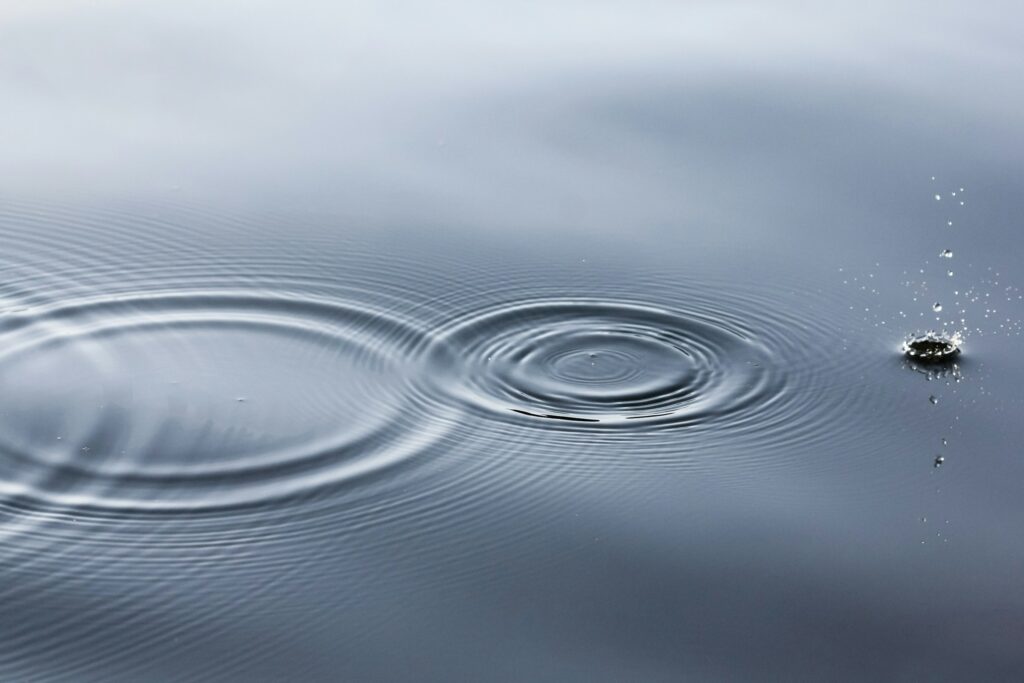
[435,300,770,429]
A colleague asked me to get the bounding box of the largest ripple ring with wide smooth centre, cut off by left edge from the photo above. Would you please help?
[0,292,443,511]
